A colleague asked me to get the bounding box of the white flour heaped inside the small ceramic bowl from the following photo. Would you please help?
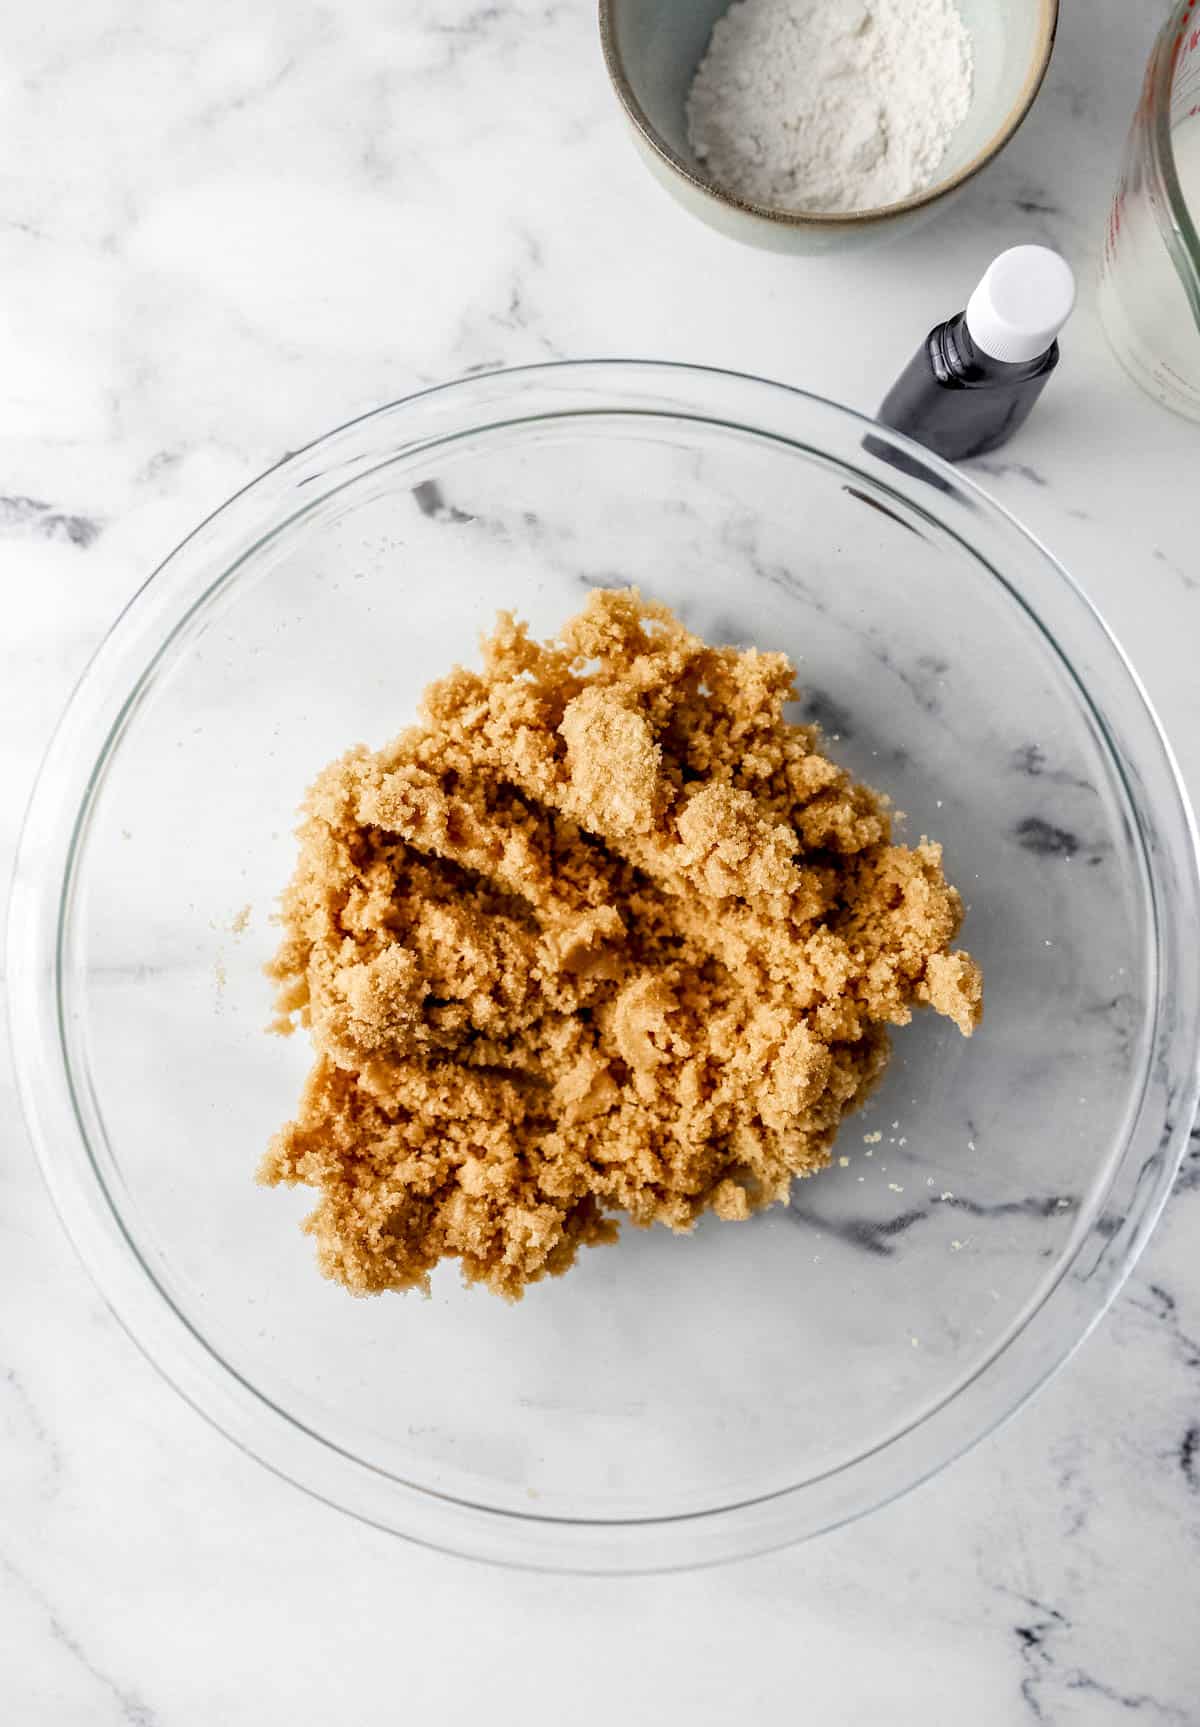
[687,0,972,211]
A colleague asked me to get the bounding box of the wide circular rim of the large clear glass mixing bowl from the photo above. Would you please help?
[9,361,1200,1572]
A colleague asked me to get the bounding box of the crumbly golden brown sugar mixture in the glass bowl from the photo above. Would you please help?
[261,591,982,1297]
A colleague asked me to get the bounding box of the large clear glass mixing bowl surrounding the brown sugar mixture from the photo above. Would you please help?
[10,363,1198,1570]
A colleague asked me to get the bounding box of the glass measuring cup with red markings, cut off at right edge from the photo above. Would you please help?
[1100,0,1200,420]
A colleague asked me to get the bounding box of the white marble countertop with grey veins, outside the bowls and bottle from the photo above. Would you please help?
[0,0,1200,1727]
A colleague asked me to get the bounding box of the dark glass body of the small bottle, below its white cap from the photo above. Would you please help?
[875,313,1058,461]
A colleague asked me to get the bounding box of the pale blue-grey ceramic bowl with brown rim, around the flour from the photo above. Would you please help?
[599,0,1058,252]
